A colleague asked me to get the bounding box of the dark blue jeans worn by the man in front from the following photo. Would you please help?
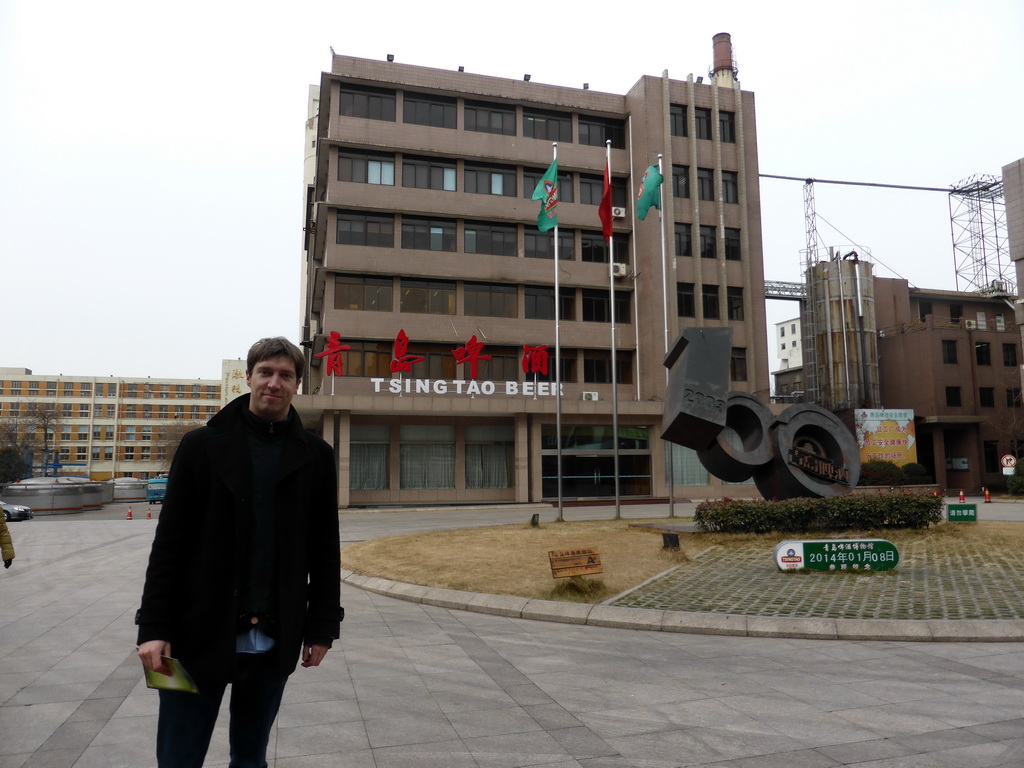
[157,653,288,768]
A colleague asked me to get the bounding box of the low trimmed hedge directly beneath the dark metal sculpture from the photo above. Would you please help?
[693,494,943,534]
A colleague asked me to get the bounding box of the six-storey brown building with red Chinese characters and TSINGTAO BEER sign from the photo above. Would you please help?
[296,36,768,506]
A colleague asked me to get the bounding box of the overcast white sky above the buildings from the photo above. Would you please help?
[0,0,1024,379]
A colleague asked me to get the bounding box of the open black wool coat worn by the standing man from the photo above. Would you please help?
[135,394,343,688]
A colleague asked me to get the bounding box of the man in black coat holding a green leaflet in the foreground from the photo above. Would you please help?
[135,337,343,768]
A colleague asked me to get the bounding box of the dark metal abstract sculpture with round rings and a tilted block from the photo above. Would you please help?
[662,328,860,499]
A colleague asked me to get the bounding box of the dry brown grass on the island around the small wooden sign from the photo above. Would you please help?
[341,520,1024,602]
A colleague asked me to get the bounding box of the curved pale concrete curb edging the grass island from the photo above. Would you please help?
[341,568,1024,643]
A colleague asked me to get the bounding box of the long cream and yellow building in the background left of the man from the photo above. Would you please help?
[0,368,221,480]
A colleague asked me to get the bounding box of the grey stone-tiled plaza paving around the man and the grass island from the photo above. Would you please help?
[0,504,1024,768]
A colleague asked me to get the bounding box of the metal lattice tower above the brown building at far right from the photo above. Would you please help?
[949,174,1017,295]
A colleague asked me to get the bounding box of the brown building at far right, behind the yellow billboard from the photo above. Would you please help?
[873,278,1024,490]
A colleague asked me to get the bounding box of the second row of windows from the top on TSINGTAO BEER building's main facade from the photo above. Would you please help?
[338,148,630,207]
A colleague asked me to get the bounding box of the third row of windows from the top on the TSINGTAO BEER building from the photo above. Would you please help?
[335,211,741,264]
